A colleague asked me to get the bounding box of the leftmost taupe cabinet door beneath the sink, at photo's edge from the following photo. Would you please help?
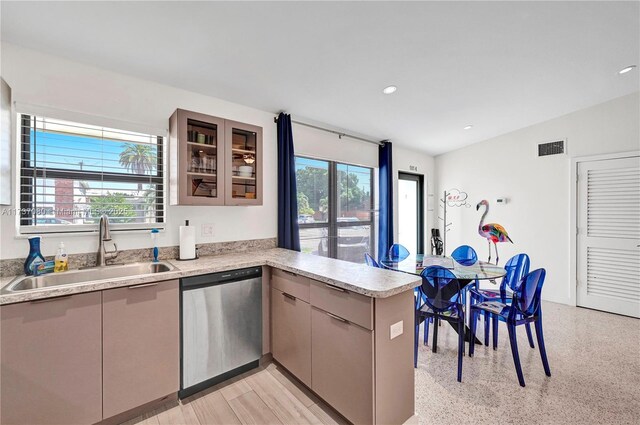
[0,292,102,425]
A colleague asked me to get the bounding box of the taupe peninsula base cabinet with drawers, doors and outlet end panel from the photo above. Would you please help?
[271,269,415,425]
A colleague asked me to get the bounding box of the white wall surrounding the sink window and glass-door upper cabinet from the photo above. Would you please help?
[0,43,277,258]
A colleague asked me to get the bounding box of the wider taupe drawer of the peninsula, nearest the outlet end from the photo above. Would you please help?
[310,281,373,330]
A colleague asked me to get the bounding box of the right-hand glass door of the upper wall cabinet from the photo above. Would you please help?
[224,120,262,205]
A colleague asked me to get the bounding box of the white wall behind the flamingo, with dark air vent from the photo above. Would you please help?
[435,93,640,304]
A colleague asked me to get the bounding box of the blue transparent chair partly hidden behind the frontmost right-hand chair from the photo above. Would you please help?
[469,254,535,350]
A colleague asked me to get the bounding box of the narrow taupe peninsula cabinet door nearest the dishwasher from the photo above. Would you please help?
[271,288,311,386]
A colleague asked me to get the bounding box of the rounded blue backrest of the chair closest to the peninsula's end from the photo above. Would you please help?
[420,266,461,312]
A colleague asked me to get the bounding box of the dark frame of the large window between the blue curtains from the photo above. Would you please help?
[295,155,376,263]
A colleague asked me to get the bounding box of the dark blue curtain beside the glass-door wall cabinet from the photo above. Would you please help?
[278,112,300,251]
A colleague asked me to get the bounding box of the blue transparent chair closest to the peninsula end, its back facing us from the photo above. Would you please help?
[413,266,465,382]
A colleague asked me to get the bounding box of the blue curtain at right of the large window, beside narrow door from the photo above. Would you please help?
[378,142,393,260]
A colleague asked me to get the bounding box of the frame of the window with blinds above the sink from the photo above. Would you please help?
[16,112,167,235]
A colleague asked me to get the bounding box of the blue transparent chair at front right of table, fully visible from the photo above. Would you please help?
[469,269,551,387]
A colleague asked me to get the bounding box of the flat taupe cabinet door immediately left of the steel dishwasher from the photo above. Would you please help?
[103,280,180,418]
